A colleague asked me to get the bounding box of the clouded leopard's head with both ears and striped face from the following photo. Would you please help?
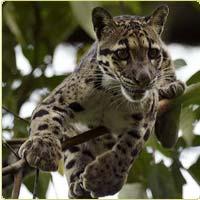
[92,5,168,102]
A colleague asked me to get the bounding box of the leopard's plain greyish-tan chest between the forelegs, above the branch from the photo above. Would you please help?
[72,91,147,134]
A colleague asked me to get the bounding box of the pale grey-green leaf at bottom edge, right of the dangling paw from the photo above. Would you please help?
[118,183,147,199]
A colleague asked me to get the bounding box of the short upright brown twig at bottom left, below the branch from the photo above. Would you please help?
[11,169,23,199]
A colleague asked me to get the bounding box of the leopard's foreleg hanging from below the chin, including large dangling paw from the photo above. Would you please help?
[81,95,158,197]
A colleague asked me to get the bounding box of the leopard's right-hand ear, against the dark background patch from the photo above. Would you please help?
[146,5,169,35]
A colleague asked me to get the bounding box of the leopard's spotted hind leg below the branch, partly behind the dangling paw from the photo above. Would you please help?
[64,131,116,198]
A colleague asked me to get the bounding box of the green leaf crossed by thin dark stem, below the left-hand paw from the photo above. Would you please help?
[24,171,51,199]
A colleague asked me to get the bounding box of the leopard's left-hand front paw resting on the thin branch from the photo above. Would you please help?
[18,135,62,171]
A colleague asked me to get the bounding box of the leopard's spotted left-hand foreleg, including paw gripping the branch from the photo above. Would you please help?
[19,90,78,171]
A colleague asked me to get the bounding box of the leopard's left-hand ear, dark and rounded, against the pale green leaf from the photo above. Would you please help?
[92,7,114,40]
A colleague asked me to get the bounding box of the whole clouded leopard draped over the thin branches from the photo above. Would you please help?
[19,6,184,198]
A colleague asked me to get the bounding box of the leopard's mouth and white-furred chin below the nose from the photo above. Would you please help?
[121,85,147,102]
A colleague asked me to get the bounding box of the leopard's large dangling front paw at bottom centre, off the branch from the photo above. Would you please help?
[81,151,127,198]
